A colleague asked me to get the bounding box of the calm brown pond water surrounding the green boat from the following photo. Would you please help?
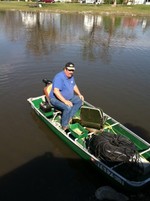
[0,12,150,201]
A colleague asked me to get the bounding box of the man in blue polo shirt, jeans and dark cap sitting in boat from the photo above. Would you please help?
[49,62,84,130]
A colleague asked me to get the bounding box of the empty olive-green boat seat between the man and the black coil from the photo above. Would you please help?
[80,106,105,130]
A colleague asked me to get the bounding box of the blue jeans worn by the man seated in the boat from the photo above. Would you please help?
[50,95,82,127]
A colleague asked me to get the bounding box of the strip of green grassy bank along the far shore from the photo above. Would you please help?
[0,1,150,16]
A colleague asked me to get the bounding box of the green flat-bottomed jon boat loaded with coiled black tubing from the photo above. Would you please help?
[28,79,150,189]
